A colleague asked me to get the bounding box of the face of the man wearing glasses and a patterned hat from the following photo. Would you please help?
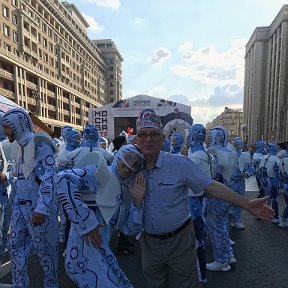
[137,128,165,158]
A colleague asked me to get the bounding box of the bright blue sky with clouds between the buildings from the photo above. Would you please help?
[66,0,288,124]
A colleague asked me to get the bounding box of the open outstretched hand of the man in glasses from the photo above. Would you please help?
[247,196,275,220]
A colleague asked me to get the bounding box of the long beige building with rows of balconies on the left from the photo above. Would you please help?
[0,0,123,135]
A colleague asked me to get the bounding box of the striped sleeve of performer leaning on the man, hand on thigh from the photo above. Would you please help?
[54,169,99,235]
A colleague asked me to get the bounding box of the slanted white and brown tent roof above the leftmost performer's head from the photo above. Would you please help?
[0,95,54,136]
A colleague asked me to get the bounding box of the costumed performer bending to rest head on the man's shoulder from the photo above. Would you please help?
[55,144,145,288]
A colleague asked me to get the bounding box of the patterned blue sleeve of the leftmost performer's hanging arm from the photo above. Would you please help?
[35,142,57,215]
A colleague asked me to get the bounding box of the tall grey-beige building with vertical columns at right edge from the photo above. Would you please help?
[243,5,288,143]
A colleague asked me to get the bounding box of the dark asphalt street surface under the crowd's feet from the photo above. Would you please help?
[0,177,288,288]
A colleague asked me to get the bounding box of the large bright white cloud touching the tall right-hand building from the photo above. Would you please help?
[171,40,247,85]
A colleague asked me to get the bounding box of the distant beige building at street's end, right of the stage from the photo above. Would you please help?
[206,107,247,143]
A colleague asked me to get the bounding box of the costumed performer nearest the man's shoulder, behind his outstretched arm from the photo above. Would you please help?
[187,124,213,283]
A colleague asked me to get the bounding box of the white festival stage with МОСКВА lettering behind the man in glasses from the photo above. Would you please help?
[88,95,193,139]
